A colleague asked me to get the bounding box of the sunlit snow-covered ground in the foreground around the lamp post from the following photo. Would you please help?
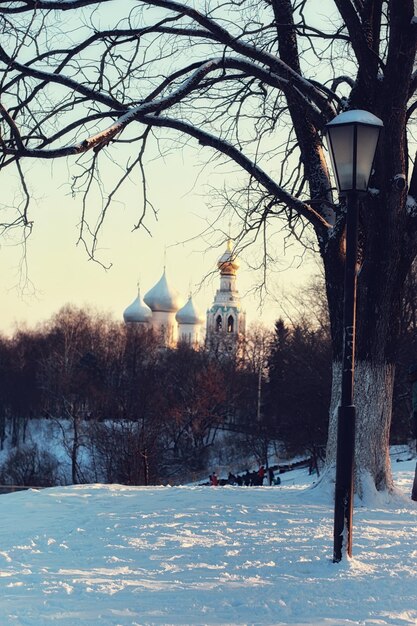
[0,461,417,626]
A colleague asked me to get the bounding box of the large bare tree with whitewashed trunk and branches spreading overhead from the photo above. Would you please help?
[0,0,417,493]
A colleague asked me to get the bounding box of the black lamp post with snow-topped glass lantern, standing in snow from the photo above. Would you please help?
[326,110,383,563]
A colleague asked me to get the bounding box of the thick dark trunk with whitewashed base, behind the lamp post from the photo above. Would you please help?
[324,191,413,498]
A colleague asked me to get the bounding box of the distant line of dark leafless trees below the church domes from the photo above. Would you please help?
[0,264,417,485]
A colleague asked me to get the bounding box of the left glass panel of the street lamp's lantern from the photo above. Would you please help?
[327,124,354,192]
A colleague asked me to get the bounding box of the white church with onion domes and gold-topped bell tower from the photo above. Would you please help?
[123,240,246,351]
